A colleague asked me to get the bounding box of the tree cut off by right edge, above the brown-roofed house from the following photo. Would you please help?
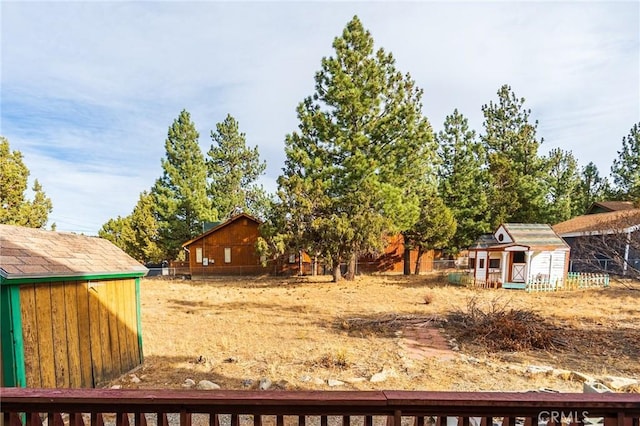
[611,123,640,203]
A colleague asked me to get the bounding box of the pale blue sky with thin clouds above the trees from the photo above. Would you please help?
[0,0,640,234]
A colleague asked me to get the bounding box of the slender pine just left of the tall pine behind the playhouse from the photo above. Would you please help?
[436,109,491,253]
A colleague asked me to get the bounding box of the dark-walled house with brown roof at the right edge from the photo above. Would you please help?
[553,208,640,275]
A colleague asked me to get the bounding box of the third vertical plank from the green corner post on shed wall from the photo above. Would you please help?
[51,282,70,388]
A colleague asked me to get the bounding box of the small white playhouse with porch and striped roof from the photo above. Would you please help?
[469,223,570,288]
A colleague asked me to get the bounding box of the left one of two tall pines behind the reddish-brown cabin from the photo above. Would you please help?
[152,110,216,259]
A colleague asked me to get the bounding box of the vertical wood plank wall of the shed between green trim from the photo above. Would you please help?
[20,278,142,388]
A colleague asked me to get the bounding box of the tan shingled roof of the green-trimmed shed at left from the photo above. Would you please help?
[0,225,147,279]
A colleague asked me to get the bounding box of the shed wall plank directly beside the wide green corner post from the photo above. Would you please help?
[20,284,42,388]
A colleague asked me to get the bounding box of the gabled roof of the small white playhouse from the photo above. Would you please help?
[471,223,569,250]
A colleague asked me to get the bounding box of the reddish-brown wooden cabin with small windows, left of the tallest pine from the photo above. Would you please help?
[182,213,269,279]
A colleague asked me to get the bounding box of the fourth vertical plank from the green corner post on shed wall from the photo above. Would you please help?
[64,281,82,388]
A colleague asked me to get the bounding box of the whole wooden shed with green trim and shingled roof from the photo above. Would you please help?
[0,225,147,388]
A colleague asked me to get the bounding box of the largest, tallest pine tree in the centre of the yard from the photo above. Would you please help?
[278,17,435,281]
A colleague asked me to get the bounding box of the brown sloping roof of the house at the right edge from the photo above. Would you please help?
[553,209,640,237]
